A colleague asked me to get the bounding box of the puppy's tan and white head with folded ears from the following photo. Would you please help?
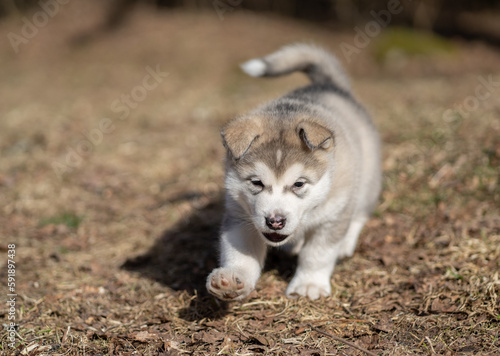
[222,116,334,246]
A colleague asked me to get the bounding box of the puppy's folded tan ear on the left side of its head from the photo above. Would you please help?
[221,117,263,160]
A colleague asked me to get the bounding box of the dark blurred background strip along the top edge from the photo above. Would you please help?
[0,0,500,44]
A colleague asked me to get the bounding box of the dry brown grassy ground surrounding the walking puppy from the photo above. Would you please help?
[0,2,500,355]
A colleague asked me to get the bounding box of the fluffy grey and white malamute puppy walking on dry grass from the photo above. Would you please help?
[207,44,381,300]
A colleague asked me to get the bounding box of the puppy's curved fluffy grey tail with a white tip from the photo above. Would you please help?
[241,43,351,91]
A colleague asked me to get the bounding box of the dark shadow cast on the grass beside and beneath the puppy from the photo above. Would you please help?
[122,193,293,321]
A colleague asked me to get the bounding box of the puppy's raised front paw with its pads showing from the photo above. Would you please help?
[207,267,253,301]
